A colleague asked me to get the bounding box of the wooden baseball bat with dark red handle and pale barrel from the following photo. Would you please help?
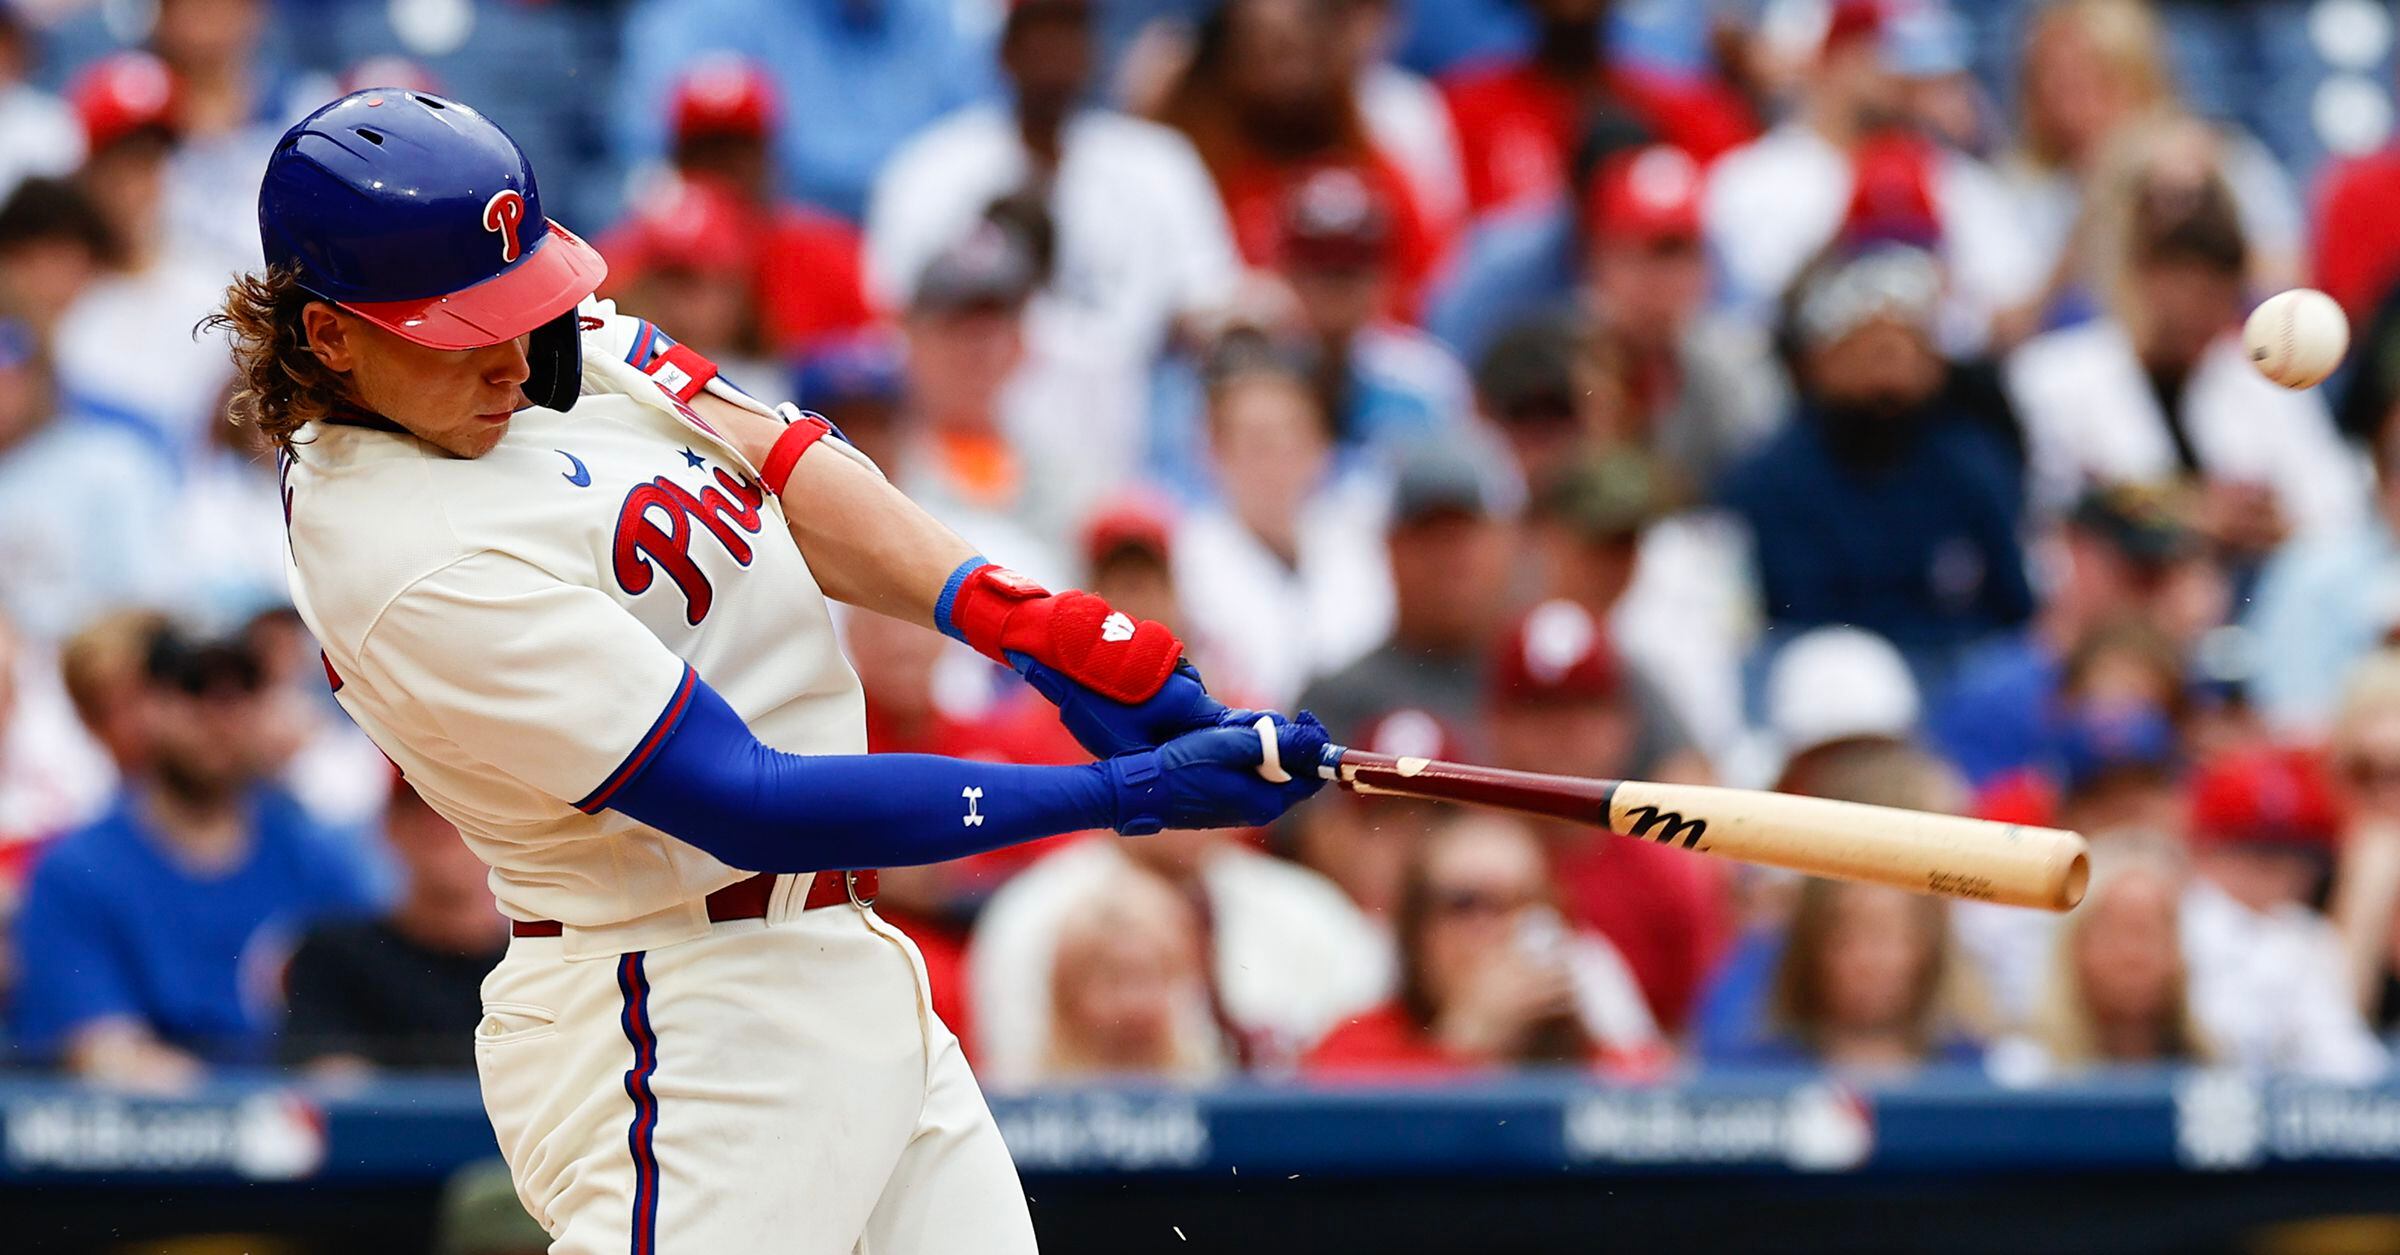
[1320,746,2090,912]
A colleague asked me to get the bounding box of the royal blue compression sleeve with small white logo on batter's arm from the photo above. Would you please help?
[593,674,1121,871]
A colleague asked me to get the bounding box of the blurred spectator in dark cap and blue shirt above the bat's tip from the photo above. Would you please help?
[1927,485,2230,787]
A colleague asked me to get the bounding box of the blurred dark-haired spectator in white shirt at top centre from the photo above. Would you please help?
[866,0,1241,468]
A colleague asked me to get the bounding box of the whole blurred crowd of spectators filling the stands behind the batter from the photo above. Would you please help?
[0,0,2400,1089]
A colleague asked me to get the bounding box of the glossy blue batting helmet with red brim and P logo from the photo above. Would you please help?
[259,86,607,408]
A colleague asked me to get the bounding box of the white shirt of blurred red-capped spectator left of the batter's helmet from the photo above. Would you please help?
[53,252,233,458]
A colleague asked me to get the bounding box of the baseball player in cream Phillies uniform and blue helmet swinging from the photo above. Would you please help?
[216,89,1325,1255]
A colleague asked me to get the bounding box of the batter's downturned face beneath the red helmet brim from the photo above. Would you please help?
[307,305,533,458]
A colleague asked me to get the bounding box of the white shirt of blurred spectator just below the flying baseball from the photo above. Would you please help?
[2006,319,2369,533]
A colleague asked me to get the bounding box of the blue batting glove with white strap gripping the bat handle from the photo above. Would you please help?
[1104,710,1327,837]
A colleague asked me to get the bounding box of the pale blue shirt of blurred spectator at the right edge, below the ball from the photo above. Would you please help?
[2242,410,2400,734]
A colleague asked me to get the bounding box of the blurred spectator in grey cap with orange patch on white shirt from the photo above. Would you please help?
[886,218,1073,588]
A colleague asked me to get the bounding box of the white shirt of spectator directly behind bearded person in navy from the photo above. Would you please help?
[1702,122,2047,350]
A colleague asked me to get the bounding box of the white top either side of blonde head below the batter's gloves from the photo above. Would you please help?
[967,837,1392,1089]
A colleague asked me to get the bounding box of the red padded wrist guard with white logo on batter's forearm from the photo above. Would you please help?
[934,557,1183,703]
